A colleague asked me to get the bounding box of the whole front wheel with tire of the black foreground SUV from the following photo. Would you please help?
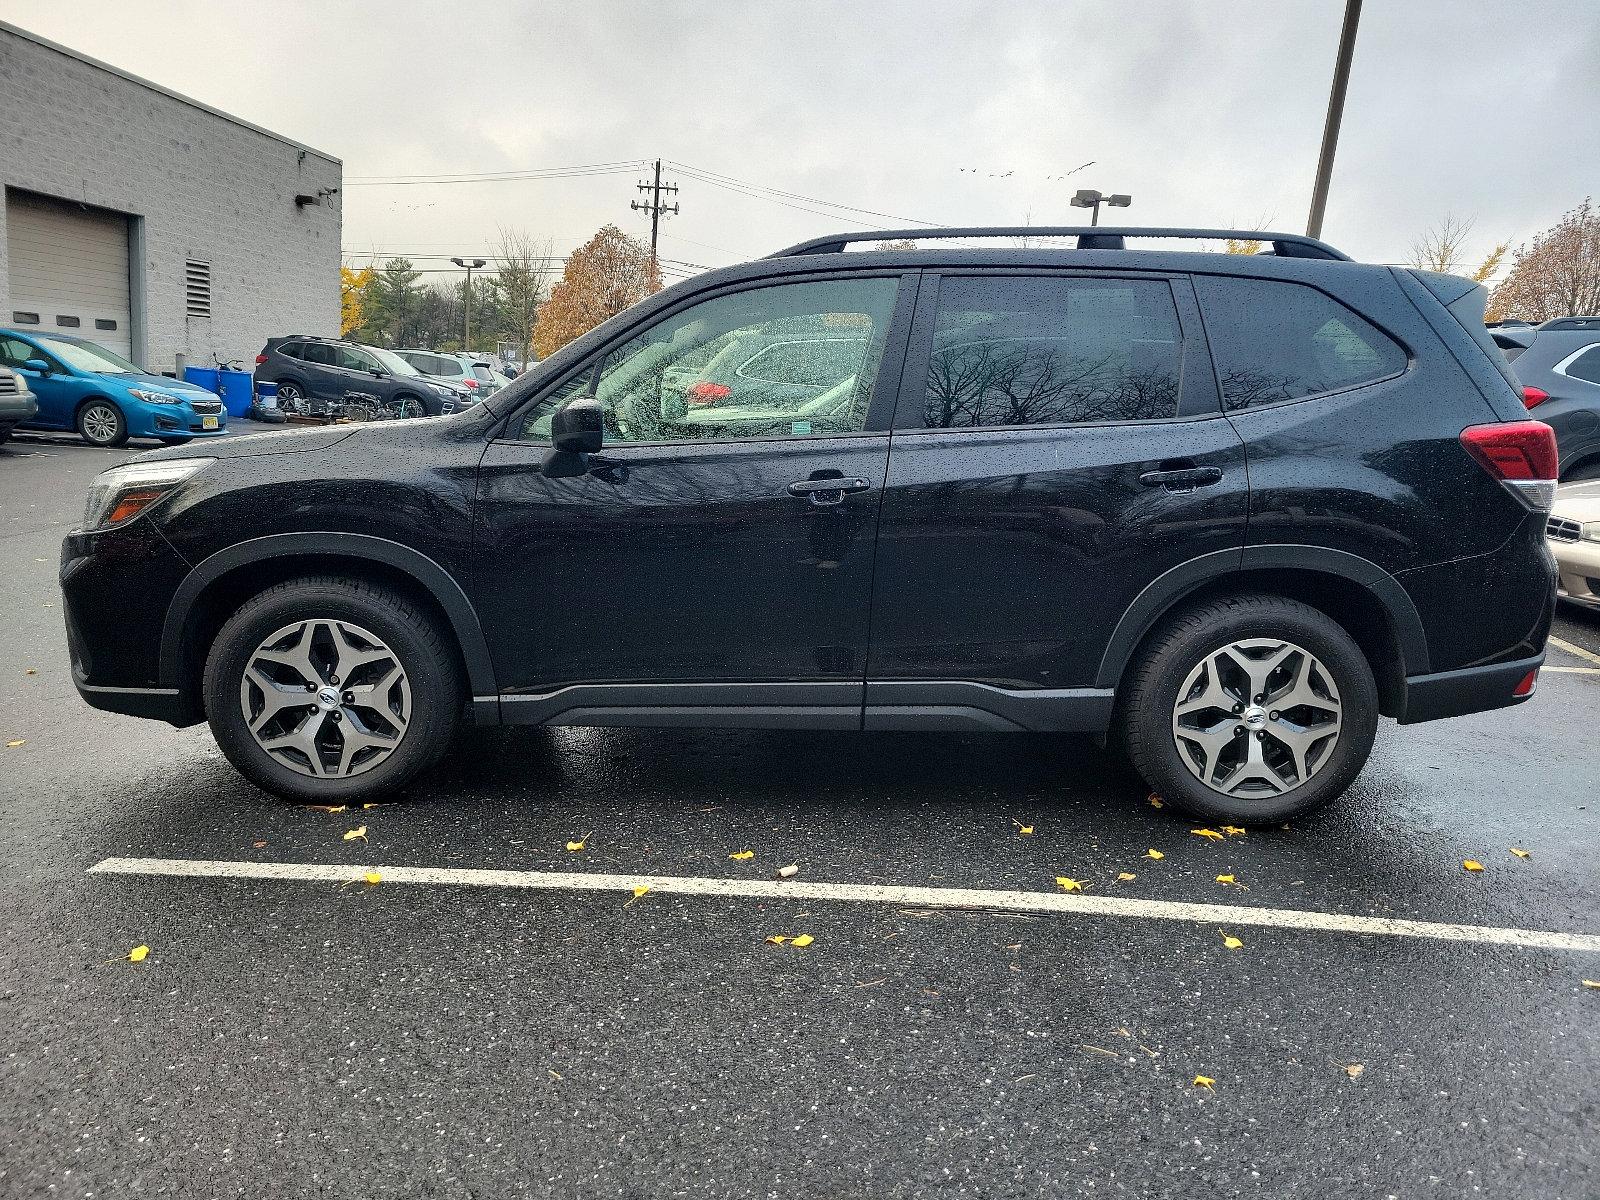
[205,578,462,803]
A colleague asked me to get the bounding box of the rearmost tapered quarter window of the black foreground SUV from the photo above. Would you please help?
[1194,275,1406,410]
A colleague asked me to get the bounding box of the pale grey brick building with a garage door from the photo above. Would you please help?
[0,21,342,371]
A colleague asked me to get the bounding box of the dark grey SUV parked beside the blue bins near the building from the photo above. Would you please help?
[256,334,458,416]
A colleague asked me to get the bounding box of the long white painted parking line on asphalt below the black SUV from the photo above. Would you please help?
[90,858,1600,952]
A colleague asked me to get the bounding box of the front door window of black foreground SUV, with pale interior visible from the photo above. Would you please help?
[522,278,898,442]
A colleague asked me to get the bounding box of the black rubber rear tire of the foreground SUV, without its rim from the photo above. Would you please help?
[1117,595,1378,826]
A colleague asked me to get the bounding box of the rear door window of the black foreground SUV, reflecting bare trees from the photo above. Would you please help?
[907,275,1182,429]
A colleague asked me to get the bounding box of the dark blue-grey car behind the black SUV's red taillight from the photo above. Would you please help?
[1490,317,1600,482]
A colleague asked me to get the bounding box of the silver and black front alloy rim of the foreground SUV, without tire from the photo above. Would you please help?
[238,619,411,779]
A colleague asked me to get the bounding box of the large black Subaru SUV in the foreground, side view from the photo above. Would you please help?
[61,229,1555,824]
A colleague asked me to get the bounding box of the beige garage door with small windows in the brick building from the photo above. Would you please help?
[0,192,131,357]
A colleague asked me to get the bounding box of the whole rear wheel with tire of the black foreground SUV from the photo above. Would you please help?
[1120,595,1378,826]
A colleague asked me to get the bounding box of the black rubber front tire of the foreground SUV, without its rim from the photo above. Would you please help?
[203,576,464,805]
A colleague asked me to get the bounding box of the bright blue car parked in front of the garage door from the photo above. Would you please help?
[0,330,227,446]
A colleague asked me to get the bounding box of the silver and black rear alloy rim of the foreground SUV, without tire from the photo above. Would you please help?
[1173,638,1344,798]
